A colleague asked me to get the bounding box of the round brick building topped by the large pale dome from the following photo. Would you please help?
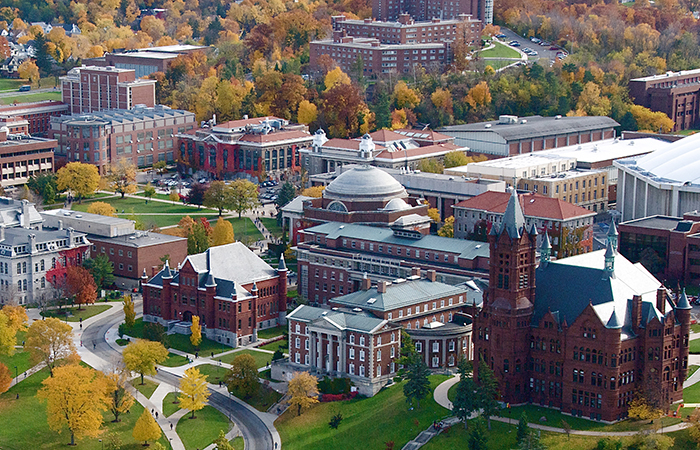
[303,165,430,230]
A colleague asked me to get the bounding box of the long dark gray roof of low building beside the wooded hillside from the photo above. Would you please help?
[437,116,620,141]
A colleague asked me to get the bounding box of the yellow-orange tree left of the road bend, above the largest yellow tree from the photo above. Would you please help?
[24,317,80,377]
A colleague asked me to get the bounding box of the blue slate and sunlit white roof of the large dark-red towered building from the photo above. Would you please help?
[534,250,673,329]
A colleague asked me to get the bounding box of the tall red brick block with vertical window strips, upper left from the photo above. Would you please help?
[61,66,156,114]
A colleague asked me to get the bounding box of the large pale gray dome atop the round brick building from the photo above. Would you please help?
[323,165,408,201]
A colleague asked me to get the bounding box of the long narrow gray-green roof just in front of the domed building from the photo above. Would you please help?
[304,222,489,260]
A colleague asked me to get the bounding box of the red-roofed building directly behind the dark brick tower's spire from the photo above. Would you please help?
[453,191,596,258]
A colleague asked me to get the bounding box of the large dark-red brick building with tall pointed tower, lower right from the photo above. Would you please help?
[474,190,691,422]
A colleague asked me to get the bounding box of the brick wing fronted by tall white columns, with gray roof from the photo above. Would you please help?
[284,305,401,396]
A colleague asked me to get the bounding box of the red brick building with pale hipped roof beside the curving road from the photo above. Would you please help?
[143,242,287,347]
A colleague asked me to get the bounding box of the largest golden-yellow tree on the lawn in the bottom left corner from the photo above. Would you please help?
[35,366,107,445]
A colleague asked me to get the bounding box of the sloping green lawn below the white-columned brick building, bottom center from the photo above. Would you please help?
[275,375,448,450]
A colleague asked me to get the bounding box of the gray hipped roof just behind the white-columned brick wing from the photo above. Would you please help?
[330,279,467,311]
